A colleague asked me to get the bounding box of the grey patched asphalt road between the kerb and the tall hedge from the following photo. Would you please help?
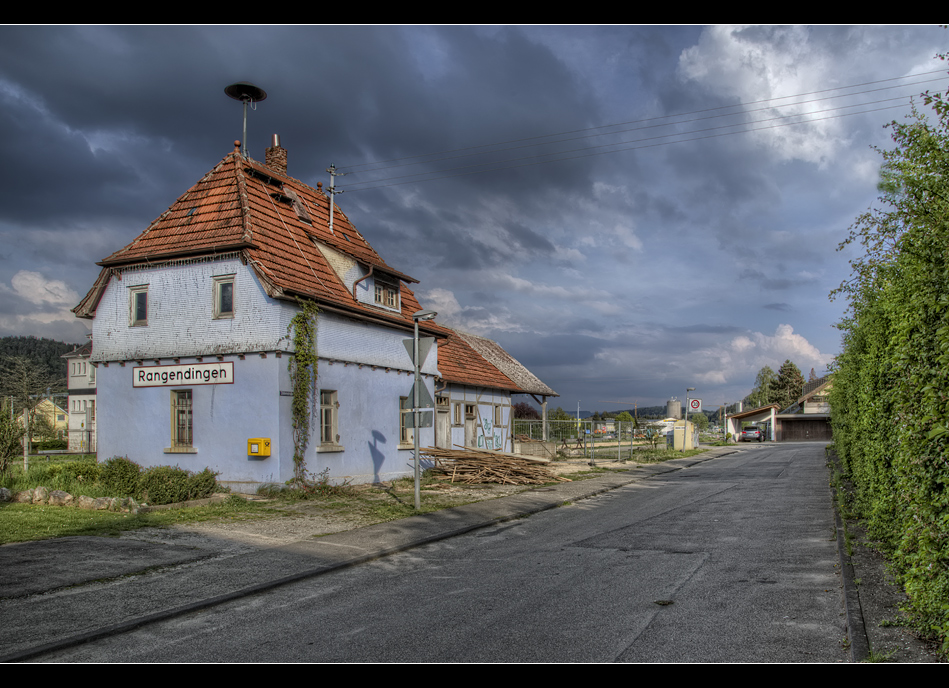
[35,443,847,662]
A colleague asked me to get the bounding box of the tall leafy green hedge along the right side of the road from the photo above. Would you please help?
[830,88,949,651]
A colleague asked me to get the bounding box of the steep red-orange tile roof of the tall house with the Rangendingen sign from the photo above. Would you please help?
[73,142,438,334]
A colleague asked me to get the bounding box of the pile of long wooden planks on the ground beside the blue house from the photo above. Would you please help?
[419,447,570,485]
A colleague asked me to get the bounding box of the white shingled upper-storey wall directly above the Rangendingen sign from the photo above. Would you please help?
[92,259,296,361]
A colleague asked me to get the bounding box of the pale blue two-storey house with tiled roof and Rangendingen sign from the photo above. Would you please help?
[74,137,560,488]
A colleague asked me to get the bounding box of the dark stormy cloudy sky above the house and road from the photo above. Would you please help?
[0,26,949,410]
